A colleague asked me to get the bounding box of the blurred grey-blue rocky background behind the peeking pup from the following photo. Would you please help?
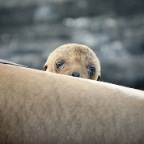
[0,0,144,90]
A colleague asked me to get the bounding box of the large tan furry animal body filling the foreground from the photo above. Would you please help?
[0,64,144,144]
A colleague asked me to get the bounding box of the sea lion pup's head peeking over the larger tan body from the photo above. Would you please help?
[44,44,101,80]
